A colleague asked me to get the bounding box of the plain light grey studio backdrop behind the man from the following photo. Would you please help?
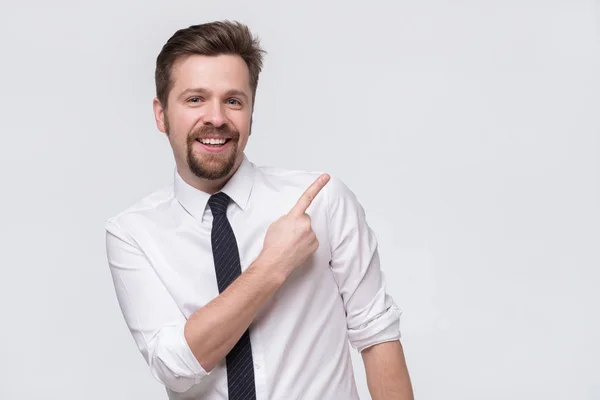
[0,0,600,400]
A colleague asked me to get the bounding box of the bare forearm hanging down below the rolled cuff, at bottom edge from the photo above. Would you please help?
[361,341,414,400]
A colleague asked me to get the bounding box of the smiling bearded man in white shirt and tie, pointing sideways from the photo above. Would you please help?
[106,21,413,400]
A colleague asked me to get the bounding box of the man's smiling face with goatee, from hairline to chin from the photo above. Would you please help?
[154,55,252,180]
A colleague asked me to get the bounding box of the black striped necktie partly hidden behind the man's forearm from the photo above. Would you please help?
[208,192,256,400]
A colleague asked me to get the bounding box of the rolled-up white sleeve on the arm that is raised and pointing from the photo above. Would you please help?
[106,221,209,392]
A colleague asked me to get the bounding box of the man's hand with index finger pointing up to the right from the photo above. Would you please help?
[261,174,330,277]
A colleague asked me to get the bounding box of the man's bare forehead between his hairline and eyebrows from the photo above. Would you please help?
[171,54,251,95]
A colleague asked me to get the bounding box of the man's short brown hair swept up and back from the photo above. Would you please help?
[154,21,266,108]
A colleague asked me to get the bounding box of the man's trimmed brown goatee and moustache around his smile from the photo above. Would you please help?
[187,125,240,180]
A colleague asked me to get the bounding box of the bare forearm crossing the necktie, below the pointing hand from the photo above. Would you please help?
[184,257,285,371]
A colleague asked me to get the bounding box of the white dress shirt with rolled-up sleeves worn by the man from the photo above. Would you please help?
[106,157,400,400]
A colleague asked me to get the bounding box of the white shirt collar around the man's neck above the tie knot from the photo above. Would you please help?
[174,155,254,221]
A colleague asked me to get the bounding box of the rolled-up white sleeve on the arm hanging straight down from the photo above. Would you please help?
[324,177,401,352]
